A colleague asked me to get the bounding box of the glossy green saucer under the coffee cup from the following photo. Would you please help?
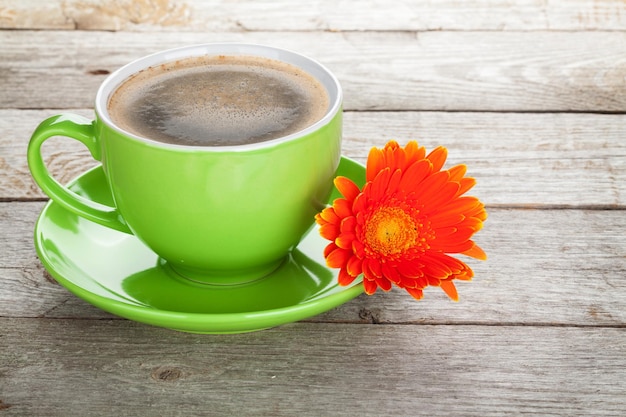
[35,158,365,333]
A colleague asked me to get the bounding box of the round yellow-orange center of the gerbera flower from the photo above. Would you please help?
[365,207,419,256]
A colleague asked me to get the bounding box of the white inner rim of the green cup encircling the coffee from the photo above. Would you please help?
[94,42,343,152]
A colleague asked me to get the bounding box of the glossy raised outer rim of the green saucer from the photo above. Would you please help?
[34,156,365,334]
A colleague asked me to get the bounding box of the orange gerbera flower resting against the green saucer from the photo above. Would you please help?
[315,141,487,301]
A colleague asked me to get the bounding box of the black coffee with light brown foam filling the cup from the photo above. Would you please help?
[108,56,329,146]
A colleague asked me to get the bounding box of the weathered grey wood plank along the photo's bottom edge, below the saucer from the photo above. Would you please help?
[0,319,626,417]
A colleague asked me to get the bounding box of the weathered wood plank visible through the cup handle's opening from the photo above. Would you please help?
[0,109,626,207]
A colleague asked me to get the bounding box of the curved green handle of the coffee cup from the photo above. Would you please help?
[27,114,132,233]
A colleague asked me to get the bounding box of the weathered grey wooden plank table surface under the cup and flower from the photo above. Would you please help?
[0,0,626,417]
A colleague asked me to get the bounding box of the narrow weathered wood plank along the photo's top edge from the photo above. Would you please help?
[0,0,626,32]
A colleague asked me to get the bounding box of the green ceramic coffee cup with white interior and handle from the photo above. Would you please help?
[28,44,342,285]
